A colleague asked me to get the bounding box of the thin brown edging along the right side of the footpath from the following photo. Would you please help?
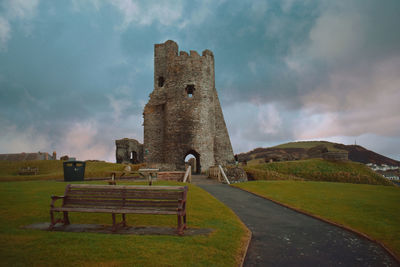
[233,186,400,264]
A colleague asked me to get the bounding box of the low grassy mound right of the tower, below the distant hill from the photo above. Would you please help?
[244,159,393,185]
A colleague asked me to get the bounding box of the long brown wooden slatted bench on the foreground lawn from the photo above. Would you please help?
[49,184,188,235]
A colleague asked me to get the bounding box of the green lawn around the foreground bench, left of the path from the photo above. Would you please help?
[0,181,248,266]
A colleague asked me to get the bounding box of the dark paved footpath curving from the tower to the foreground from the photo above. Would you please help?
[198,183,399,267]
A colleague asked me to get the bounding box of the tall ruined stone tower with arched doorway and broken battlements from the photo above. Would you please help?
[143,40,234,172]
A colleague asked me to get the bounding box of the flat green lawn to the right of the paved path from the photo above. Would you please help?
[234,181,400,256]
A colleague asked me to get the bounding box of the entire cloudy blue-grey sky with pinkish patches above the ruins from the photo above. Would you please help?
[0,0,400,162]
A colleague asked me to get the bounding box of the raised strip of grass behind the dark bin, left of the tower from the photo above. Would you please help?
[0,160,140,181]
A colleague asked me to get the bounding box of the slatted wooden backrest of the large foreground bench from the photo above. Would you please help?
[63,184,188,211]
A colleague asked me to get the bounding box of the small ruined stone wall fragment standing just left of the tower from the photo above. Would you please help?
[115,138,143,164]
